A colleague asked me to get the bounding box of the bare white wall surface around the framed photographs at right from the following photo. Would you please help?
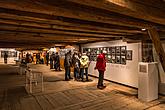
[82,40,141,87]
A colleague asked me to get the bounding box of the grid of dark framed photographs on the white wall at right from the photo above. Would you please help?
[83,46,132,65]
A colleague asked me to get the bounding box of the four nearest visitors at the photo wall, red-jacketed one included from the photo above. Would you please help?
[64,51,106,89]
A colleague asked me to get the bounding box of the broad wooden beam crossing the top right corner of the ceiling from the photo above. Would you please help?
[66,0,165,25]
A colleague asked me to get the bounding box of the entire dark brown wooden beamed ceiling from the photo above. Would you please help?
[0,0,165,47]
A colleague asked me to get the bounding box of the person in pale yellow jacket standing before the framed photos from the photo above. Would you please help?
[80,53,89,81]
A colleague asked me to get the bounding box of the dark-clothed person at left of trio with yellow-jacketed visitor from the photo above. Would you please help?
[64,51,73,81]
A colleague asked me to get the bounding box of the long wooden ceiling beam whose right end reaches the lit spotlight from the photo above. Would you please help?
[0,16,143,33]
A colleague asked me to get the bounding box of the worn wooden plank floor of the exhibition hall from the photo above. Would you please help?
[0,65,165,110]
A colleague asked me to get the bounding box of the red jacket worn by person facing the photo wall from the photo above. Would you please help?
[96,53,106,71]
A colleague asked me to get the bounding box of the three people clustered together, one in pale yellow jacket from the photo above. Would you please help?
[64,51,89,81]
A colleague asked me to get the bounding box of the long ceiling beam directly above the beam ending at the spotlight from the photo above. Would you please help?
[0,5,154,28]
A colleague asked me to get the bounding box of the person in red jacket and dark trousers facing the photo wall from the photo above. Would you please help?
[95,51,106,89]
